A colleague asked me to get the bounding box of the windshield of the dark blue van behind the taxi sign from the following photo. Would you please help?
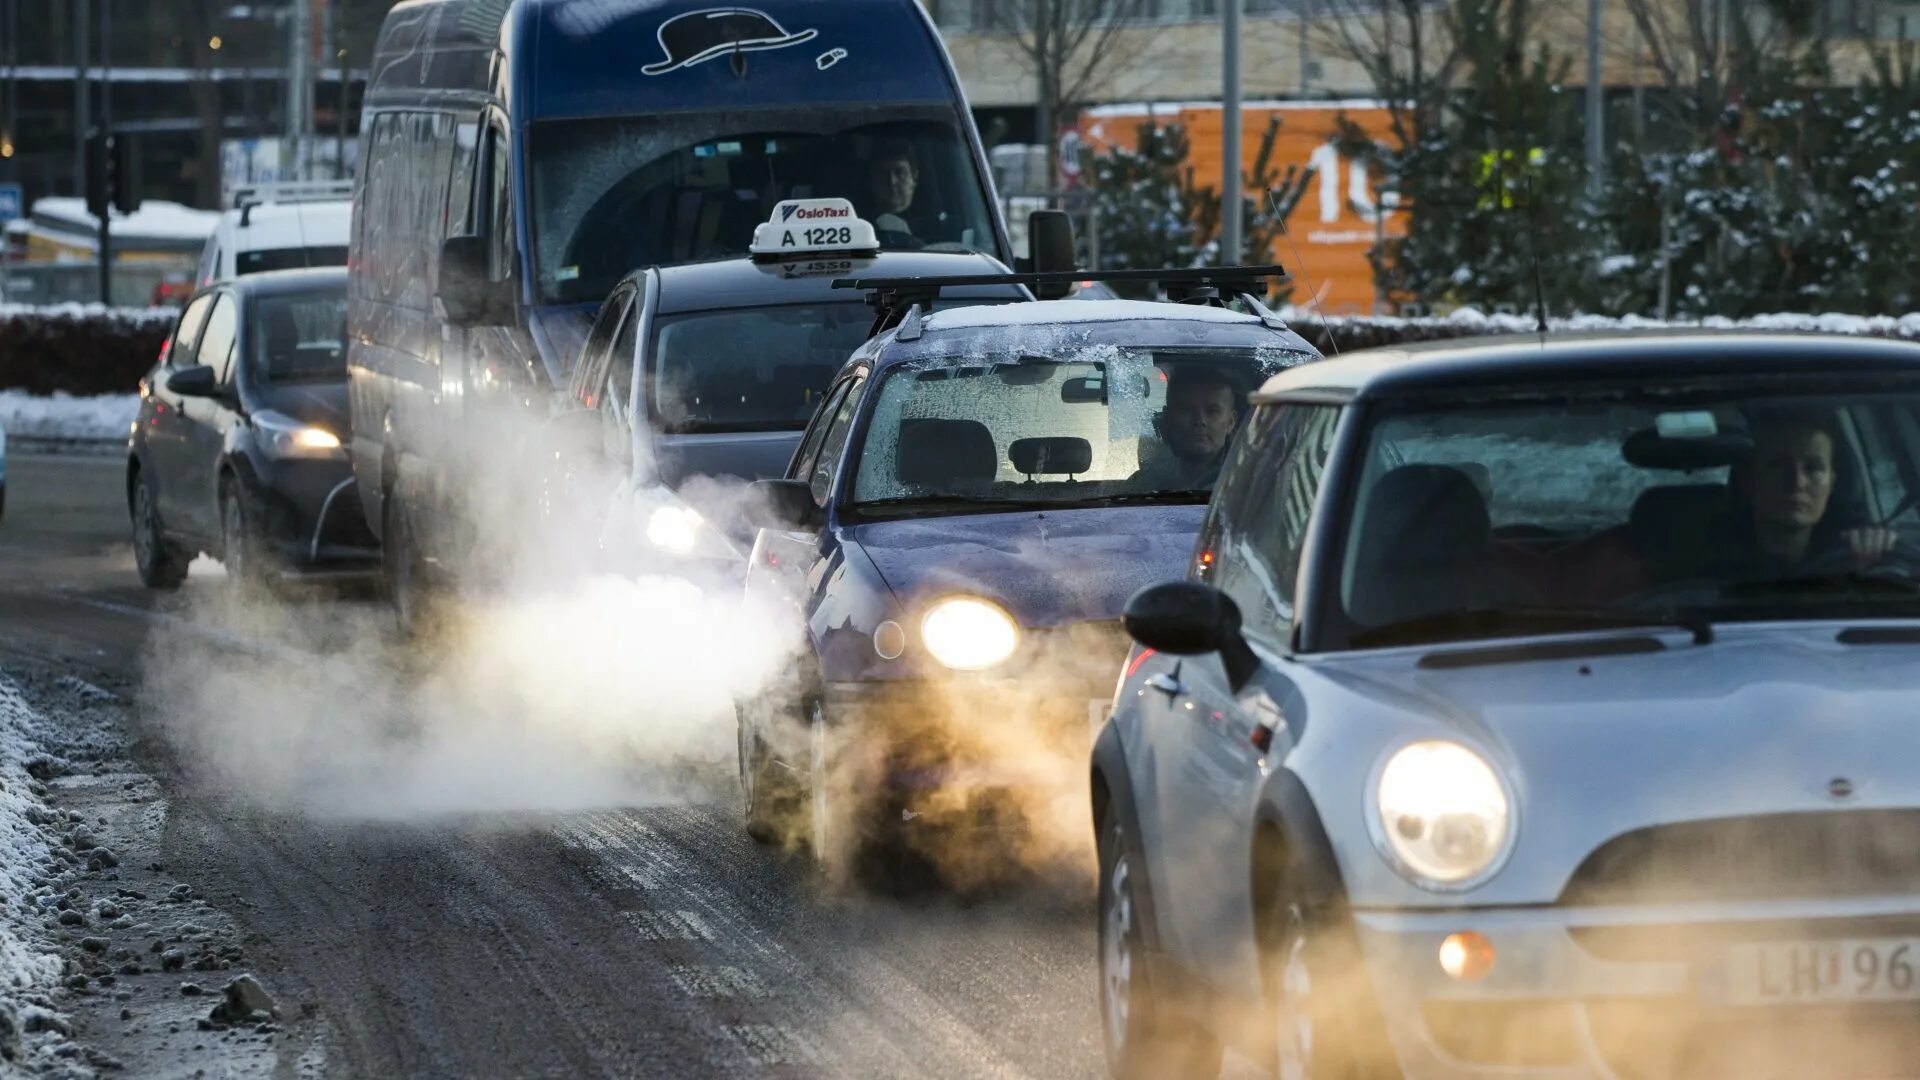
[530,106,1002,304]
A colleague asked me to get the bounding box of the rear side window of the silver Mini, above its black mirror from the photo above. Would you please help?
[1212,405,1340,648]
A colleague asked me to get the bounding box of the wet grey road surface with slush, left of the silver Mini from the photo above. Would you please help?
[0,455,1100,1076]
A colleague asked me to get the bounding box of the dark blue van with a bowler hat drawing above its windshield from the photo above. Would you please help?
[349,0,1014,617]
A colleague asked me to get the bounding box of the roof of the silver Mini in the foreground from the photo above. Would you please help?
[1254,329,1920,404]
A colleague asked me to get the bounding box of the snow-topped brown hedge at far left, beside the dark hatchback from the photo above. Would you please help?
[0,304,179,394]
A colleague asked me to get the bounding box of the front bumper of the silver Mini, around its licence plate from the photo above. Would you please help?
[1354,896,1920,1080]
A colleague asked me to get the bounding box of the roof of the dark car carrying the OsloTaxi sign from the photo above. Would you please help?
[636,252,1036,315]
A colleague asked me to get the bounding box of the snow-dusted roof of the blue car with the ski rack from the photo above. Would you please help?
[854,300,1317,365]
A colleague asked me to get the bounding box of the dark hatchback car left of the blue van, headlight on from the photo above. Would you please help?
[127,269,380,588]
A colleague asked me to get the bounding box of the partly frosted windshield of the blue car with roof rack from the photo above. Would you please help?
[852,346,1302,513]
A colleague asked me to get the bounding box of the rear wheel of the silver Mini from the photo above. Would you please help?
[1098,809,1221,1080]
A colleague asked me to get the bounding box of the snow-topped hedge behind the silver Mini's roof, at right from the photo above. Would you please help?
[1281,306,1920,356]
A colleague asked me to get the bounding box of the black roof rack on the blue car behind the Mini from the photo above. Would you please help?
[833,265,1288,336]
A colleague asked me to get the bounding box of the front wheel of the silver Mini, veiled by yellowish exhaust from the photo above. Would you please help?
[1265,868,1400,1080]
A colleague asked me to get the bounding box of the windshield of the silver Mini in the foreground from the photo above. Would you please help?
[1329,384,1920,648]
